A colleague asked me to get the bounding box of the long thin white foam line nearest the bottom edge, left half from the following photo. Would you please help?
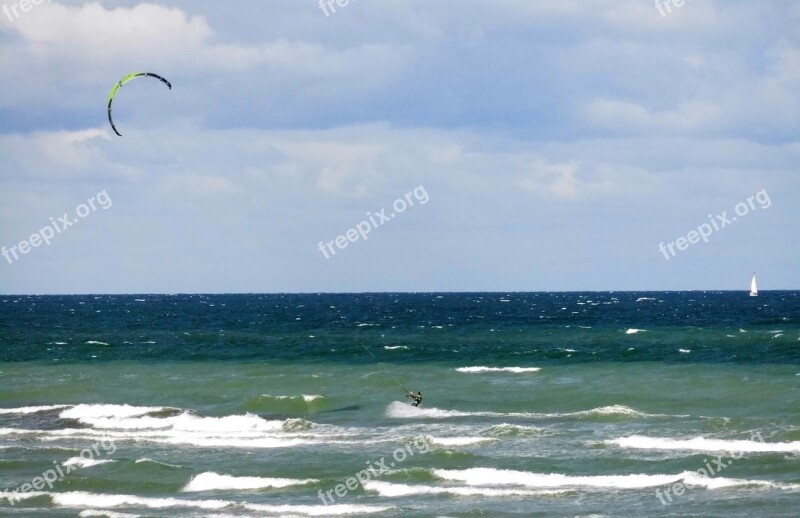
[47,491,391,516]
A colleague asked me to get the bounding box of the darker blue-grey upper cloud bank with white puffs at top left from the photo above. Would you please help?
[0,0,800,139]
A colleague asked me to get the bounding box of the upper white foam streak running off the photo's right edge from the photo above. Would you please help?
[605,435,800,453]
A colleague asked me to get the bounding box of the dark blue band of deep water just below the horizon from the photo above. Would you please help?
[0,291,800,364]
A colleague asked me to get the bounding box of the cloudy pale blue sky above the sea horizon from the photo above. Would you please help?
[0,0,800,294]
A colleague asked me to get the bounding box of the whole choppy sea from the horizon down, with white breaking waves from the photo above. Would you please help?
[0,291,800,517]
